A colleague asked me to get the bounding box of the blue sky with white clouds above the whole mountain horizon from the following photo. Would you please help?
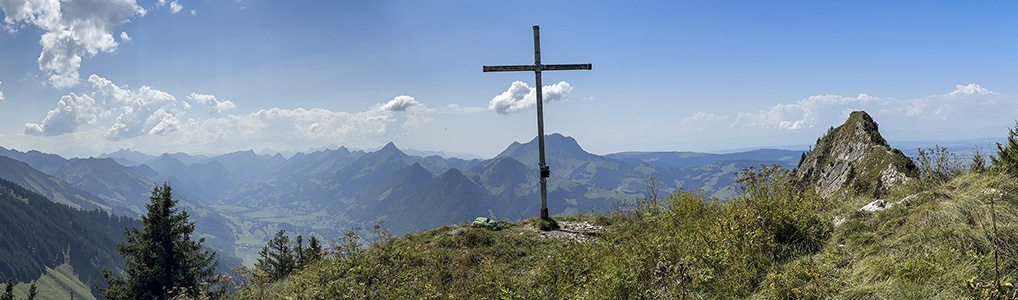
[0,0,1018,157]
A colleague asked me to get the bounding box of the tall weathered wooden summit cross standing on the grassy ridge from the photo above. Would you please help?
[485,25,591,219]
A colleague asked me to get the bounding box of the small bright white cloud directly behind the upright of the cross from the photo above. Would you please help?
[488,81,572,115]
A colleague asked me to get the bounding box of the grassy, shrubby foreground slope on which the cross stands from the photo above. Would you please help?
[238,174,1018,299]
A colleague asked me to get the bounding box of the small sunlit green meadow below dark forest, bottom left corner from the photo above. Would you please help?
[14,263,96,300]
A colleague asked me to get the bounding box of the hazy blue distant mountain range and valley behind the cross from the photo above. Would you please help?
[0,134,801,263]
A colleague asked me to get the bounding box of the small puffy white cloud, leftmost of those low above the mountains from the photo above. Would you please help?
[24,93,97,136]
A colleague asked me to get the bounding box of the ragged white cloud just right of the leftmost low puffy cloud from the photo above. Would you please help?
[89,74,180,140]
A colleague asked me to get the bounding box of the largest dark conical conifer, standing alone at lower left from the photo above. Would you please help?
[96,183,224,300]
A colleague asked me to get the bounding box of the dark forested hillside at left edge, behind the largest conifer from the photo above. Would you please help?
[0,179,140,296]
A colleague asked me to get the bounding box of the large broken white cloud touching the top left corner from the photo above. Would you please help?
[0,0,146,87]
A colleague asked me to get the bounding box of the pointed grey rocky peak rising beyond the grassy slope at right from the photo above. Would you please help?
[796,111,916,197]
